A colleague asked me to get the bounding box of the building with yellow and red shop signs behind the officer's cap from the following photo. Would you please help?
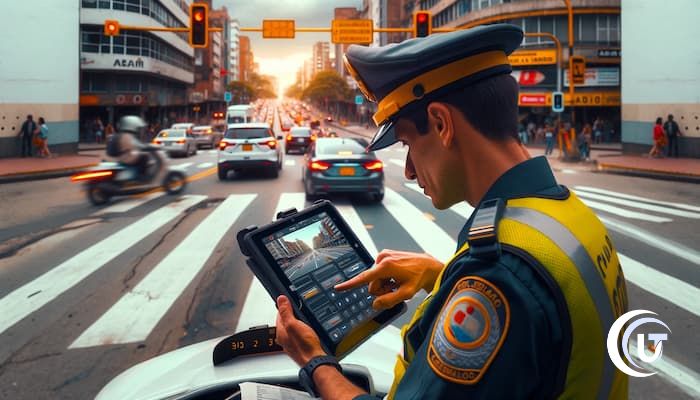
[416,0,621,141]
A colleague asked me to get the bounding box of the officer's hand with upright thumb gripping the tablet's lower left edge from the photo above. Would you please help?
[277,296,326,367]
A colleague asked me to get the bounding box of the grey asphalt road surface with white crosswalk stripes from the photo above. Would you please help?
[0,108,700,399]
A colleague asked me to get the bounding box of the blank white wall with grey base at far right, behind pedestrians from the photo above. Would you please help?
[622,0,700,158]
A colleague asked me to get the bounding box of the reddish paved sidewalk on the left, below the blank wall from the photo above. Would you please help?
[0,154,102,184]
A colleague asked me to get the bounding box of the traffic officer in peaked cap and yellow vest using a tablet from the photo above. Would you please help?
[277,24,627,399]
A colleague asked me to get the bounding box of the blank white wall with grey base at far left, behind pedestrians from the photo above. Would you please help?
[0,0,80,157]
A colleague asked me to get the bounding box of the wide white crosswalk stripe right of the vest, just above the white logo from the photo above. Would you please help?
[617,253,700,317]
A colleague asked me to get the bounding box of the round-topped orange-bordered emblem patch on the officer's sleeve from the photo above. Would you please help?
[427,276,510,385]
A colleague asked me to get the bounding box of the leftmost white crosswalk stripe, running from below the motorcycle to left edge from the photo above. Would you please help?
[0,195,207,333]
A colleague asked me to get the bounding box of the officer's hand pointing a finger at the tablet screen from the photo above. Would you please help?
[335,250,444,309]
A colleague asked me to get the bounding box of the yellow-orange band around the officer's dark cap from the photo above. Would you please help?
[372,50,510,125]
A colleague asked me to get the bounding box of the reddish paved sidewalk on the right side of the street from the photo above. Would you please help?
[330,124,700,183]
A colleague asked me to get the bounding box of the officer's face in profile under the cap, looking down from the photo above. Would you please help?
[395,114,463,210]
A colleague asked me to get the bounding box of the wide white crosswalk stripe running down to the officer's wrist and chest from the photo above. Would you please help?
[383,188,457,262]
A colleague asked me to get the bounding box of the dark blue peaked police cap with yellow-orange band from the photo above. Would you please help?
[343,24,523,150]
